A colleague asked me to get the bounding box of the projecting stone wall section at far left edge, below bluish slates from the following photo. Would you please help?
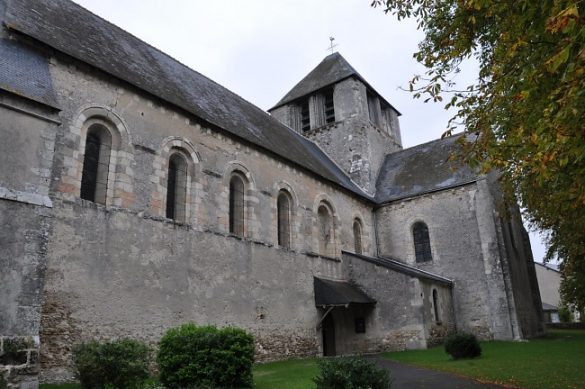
[0,73,58,388]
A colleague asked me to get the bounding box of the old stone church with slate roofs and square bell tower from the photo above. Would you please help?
[0,0,544,388]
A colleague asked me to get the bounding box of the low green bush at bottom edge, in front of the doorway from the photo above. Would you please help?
[313,357,390,389]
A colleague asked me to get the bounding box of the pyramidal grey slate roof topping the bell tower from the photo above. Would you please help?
[269,53,400,115]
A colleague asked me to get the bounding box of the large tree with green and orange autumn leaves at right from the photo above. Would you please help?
[372,0,585,309]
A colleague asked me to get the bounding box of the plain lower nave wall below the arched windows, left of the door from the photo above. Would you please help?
[41,201,342,380]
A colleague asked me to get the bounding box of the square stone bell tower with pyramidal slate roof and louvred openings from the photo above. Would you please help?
[269,53,402,195]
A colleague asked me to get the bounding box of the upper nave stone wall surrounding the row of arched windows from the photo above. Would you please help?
[46,54,374,256]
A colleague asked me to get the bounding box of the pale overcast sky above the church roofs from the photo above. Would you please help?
[76,0,544,260]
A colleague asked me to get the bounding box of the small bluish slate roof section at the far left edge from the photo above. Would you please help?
[0,39,57,108]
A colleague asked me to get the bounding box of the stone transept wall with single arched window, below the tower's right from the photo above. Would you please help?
[377,183,514,339]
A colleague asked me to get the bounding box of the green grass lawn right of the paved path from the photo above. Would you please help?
[383,330,585,388]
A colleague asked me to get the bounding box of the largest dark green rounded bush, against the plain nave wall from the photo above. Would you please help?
[157,324,254,389]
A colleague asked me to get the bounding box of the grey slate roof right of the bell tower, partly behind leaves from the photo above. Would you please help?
[376,136,477,203]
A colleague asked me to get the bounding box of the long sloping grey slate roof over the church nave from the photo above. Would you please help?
[5,0,370,198]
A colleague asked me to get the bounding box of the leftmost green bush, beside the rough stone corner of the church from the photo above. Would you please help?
[73,339,150,389]
